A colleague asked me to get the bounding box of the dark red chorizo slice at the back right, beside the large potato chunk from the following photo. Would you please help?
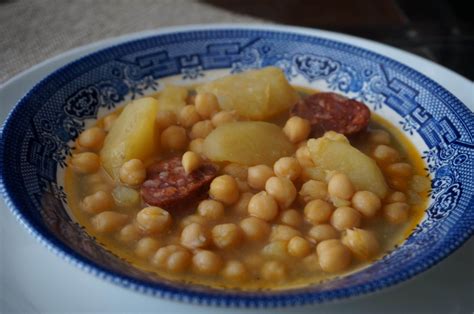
[291,93,370,137]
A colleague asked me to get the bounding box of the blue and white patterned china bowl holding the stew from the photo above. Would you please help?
[0,26,474,307]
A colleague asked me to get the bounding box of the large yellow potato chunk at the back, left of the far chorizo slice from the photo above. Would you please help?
[197,67,298,120]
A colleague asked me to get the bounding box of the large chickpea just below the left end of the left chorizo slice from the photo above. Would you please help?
[137,206,172,234]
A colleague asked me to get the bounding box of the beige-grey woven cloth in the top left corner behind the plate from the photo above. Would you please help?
[0,0,262,84]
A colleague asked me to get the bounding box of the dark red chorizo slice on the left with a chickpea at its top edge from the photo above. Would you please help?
[140,157,217,209]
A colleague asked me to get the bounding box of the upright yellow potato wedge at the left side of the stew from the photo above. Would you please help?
[100,97,158,179]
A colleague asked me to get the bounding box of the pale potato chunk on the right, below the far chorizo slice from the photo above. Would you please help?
[308,135,387,198]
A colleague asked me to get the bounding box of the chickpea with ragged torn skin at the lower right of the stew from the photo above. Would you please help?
[341,228,380,260]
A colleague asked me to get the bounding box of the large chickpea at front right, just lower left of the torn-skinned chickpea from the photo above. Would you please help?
[316,239,351,273]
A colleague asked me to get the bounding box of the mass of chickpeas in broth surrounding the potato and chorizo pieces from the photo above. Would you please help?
[69,87,430,288]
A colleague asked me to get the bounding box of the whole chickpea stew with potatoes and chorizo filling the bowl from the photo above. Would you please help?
[66,68,430,290]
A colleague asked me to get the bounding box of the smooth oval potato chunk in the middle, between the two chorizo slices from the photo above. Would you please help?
[203,121,295,166]
